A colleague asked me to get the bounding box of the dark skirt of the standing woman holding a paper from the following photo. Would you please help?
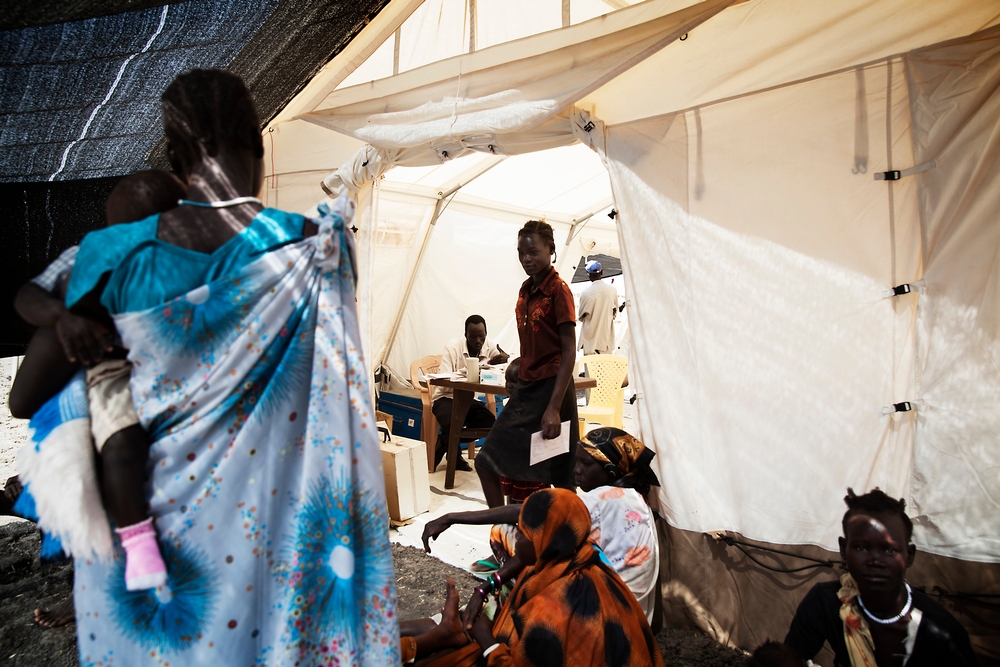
[476,377,580,488]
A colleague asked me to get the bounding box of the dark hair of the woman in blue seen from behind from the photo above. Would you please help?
[161,69,264,173]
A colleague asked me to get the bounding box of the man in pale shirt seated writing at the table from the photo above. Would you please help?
[431,315,507,471]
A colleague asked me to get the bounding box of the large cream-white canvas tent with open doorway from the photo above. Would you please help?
[265,0,1000,658]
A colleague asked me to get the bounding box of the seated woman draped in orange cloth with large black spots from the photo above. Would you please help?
[420,489,663,667]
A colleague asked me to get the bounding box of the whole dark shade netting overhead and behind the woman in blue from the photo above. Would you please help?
[0,0,388,355]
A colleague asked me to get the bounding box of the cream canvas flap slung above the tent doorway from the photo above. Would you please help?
[303,0,733,152]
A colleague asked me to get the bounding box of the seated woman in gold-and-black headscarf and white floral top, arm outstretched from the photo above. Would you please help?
[423,428,660,622]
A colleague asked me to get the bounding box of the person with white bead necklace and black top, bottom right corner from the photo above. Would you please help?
[785,488,976,667]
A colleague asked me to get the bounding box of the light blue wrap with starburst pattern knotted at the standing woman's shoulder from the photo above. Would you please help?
[75,208,399,667]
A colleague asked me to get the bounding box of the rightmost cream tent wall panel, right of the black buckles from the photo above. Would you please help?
[907,30,1000,562]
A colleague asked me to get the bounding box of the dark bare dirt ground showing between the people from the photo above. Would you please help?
[0,522,744,667]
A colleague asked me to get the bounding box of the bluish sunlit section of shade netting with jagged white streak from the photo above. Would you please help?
[0,0,277,181]
